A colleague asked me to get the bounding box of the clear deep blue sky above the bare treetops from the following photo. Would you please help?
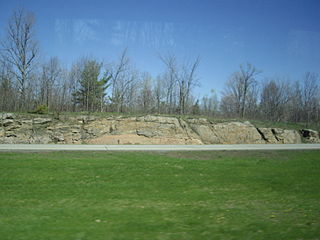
[0,0,320,95]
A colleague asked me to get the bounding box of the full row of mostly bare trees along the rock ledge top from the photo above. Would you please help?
[0,9,320,123]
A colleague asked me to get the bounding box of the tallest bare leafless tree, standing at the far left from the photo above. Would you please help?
[1,9,38,109]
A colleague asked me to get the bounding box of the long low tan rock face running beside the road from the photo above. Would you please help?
[0,113,319,144]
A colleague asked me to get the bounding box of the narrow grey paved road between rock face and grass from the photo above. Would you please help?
[0,144,320,151]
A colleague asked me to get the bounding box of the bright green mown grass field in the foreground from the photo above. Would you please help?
[0,151,320,240]
